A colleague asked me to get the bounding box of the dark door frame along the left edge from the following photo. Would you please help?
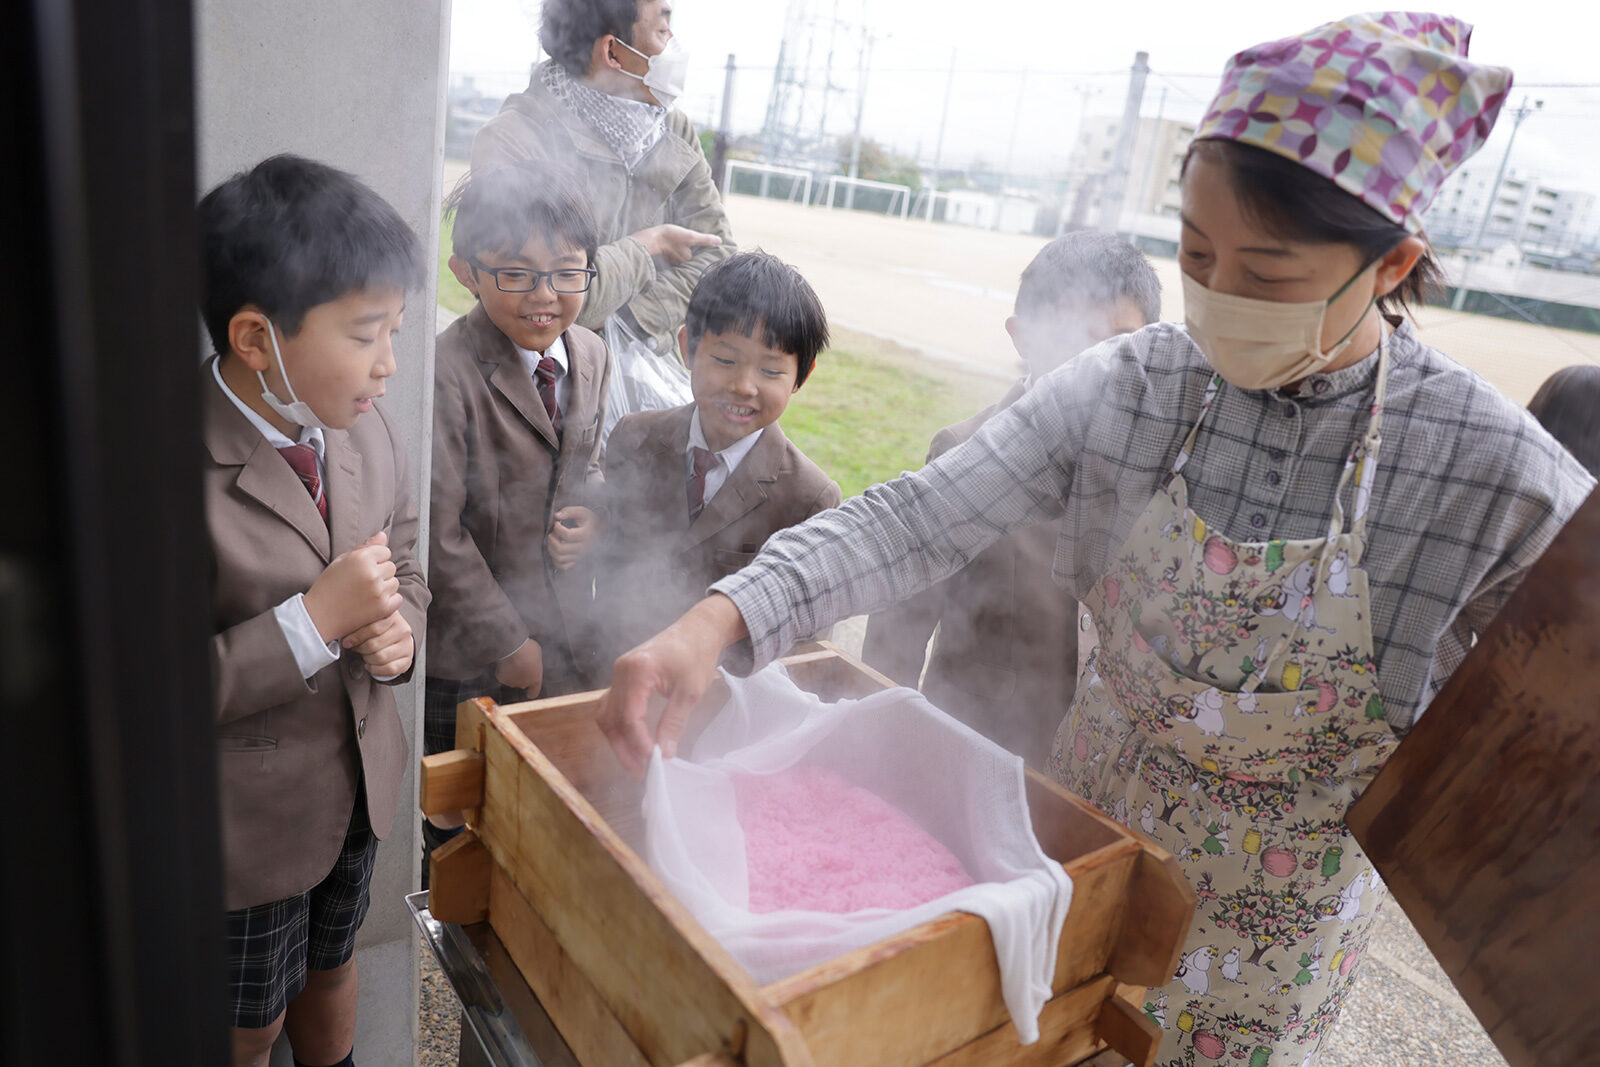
[0,0,229,1067]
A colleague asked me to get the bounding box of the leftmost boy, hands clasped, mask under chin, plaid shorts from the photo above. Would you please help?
[198,155,427,1064]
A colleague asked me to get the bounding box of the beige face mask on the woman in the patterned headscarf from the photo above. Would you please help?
[1184,267,1376,389]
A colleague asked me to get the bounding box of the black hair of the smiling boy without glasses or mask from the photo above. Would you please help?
[685,251,827,389]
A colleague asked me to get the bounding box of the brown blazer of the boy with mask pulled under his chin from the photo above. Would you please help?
[202,365,427,910]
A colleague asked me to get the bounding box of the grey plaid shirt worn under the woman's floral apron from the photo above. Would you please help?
[712,323,1595,729]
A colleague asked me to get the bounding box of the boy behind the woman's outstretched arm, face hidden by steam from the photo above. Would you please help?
[862,230,1162,766]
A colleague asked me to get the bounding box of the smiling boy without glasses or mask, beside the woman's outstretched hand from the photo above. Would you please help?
[597,253,842,669]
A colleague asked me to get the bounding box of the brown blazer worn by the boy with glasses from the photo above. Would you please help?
[427,304,610,696]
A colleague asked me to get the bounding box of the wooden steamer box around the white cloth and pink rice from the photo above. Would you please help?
[444,646,1194,1067]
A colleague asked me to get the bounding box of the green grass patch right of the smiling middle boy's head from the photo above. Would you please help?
[782,328,1008,499]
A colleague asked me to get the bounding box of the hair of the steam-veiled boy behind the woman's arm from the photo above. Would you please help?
[1016,230,1162,323]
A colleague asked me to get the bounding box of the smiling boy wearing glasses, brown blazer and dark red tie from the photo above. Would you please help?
[424,163,608,783]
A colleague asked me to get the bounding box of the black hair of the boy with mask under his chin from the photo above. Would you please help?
[197,154,426,352]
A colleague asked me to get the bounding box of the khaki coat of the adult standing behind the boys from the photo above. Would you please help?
[472,61,734,363]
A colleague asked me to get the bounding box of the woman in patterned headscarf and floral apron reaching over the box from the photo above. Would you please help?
[602,13,1594,1064]
